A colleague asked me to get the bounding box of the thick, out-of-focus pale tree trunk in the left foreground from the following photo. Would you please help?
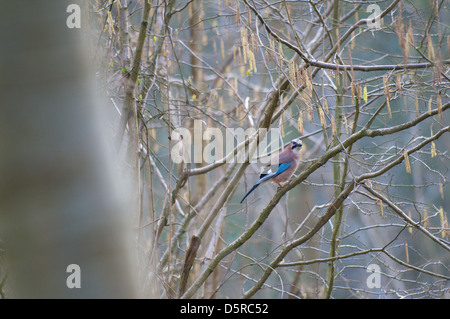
[0,0,135,298]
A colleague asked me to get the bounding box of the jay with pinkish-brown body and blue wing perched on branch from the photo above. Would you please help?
[241,138,302,203]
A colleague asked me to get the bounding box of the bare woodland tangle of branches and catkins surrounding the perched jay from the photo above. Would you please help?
[0,0,450,298]
